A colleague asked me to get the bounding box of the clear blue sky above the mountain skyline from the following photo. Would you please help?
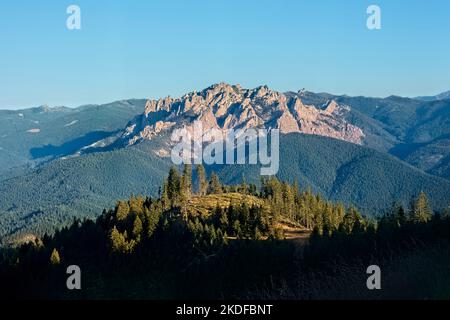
[0,0,450,109]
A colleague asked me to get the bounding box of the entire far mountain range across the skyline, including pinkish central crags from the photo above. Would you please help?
[0,83,450,179]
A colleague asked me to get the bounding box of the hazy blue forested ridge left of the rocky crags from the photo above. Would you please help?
[0,99,146,180]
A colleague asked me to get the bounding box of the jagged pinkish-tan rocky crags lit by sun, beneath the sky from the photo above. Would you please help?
[122,83,364,145]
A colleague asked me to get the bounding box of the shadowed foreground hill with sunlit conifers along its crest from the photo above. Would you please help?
[0,166,450,299]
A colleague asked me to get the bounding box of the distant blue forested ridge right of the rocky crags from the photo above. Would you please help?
[290,91,450,179]
